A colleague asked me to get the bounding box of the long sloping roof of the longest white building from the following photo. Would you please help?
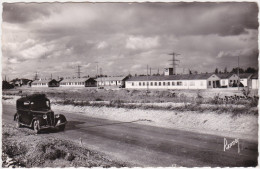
[126,73,214,81]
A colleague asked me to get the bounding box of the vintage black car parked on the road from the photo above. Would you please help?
[14,94,67,133]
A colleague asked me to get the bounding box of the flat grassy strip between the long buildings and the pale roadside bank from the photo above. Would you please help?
[3,87,258,115]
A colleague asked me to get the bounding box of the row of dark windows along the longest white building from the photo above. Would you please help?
[132,81,204,86]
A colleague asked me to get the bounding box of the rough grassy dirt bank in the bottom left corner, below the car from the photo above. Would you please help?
[2,123,127,168]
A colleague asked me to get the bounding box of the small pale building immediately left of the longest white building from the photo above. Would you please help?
[96,76,128,86]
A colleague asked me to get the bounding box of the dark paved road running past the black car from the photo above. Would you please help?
[3,105,258,167]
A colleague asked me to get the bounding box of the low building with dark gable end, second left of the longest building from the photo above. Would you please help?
[60,78,97,87]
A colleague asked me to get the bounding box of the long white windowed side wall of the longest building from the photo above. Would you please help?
[125,80,207,89]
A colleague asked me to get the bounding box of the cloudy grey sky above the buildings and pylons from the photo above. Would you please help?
[2,2,258,79]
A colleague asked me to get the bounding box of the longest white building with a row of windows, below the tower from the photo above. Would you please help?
[125,73,221,89]
